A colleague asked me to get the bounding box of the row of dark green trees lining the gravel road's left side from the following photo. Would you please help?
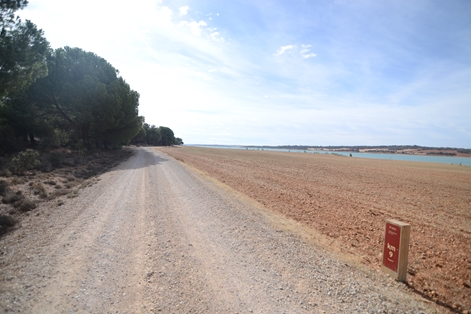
[0,0,182,153]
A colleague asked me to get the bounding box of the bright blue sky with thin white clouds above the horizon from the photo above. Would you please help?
[21,0,471,148]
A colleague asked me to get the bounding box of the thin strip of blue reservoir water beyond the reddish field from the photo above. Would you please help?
[192,145,471,166]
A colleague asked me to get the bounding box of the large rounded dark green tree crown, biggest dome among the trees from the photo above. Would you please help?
[32,47,142,148]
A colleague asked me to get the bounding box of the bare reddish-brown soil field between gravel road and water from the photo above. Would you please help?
[161,147,471,313]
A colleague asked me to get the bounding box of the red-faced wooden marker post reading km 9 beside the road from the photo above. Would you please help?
[381,219,410,281]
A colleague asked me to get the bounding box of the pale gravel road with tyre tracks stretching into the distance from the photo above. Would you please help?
[0,148,445,313]
